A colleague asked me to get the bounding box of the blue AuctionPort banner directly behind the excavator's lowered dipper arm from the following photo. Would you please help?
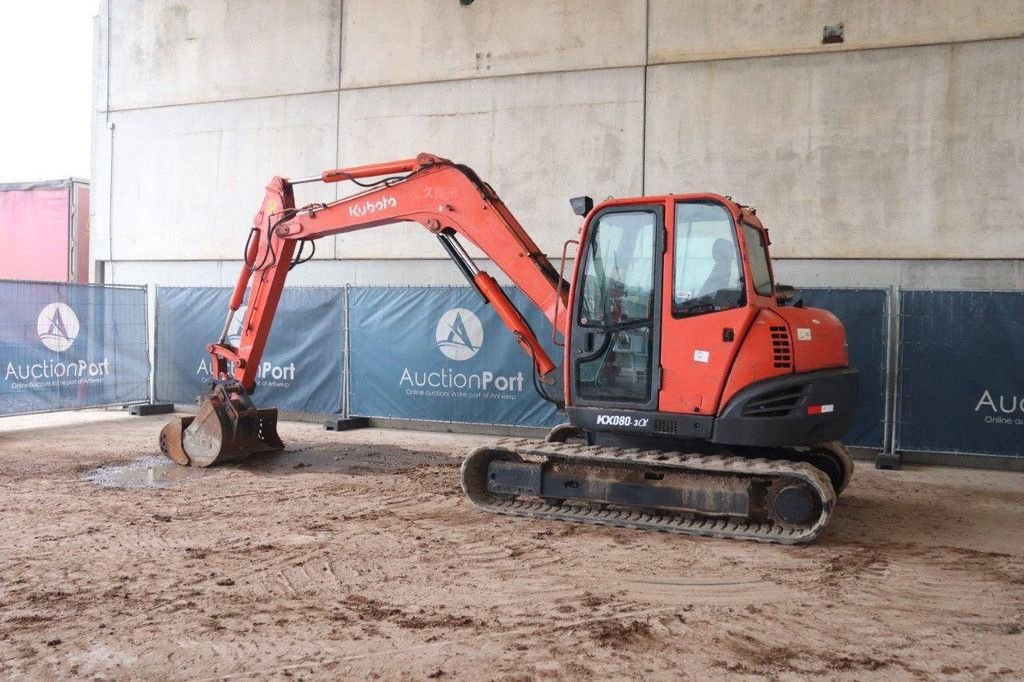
[156,287,344,413]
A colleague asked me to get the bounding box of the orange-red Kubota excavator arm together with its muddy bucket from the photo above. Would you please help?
[160,154,568,466]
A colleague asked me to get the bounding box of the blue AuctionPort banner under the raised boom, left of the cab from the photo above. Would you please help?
[349,287,564,427]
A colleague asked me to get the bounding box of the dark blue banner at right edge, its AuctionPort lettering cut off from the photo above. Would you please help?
[896,291,1024,457]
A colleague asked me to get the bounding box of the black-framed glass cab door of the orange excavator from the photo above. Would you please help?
[569,204,665,410]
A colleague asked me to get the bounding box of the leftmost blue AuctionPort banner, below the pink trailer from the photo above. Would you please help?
[0,282,150,415]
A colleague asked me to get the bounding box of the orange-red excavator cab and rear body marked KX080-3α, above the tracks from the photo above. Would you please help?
[565,194,857,452]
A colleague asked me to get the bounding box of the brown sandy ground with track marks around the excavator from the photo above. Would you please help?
[0,405,1024,680]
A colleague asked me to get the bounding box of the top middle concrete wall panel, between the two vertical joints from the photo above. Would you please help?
[341,0,646,87]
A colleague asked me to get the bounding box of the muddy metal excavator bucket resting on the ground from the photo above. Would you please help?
[160,378,285,467]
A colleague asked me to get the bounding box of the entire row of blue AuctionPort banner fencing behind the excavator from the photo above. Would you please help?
[0,283,1024,457]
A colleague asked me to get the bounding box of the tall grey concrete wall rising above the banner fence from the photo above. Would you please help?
[92,0,1024,288]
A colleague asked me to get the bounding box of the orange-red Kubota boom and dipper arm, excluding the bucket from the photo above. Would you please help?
[214,154,567,391]
